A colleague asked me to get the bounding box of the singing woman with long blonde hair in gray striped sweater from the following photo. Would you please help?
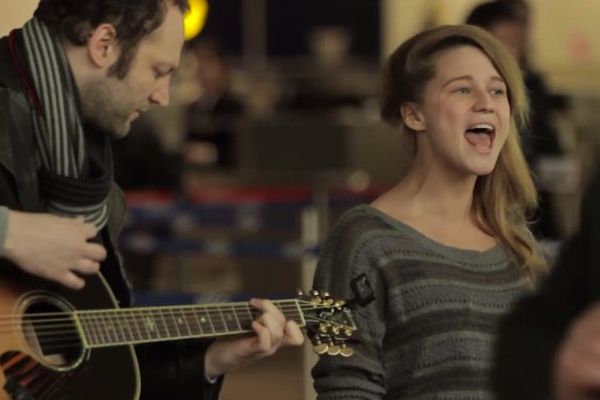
[313,26,544,400]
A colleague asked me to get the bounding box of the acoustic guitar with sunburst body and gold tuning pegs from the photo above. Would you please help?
[0,271,356,400]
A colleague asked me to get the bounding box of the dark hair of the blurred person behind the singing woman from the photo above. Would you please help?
[465,0,529,30]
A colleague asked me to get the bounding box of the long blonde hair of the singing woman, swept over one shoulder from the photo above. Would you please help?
[381,25,546,278]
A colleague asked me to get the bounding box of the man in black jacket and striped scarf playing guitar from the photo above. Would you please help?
[0,0,303,400]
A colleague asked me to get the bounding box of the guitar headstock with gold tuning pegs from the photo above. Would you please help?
[298,290,356,357]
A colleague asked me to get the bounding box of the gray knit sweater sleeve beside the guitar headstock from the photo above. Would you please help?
[312,214,385,400]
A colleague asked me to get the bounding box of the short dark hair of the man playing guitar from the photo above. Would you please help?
[34,0,188,79]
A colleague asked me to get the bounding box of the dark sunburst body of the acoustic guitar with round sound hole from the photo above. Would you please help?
[0,268,140,400]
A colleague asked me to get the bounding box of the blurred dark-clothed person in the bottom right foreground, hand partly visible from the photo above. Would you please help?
[493,179,600,400]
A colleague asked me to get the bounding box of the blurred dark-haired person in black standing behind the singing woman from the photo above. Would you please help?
[466,0,562,244]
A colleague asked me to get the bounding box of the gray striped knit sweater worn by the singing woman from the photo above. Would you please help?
[312,205,529,400]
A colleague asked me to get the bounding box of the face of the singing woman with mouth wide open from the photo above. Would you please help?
[405,45,510,176]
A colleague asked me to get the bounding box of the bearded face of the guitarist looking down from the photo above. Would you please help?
[81,2,184,138]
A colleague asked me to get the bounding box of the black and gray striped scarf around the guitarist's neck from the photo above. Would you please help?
[22,18,112,229]
